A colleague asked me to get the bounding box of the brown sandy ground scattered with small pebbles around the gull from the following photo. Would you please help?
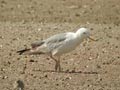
[0,0,120,90]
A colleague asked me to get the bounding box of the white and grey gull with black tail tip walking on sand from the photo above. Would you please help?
[17,28,96,72]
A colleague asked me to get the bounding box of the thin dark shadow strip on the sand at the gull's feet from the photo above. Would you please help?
[41,70,98,74]
